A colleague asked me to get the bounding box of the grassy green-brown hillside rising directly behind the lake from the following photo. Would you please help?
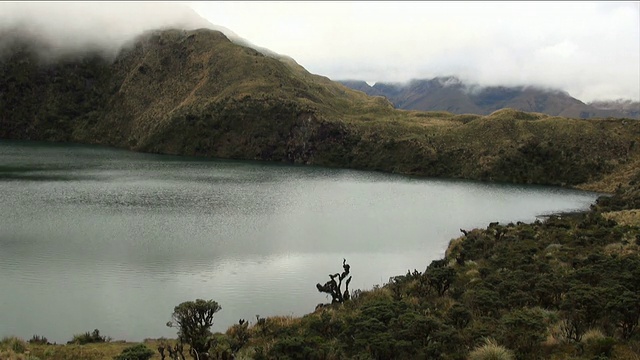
[0,29,640,191]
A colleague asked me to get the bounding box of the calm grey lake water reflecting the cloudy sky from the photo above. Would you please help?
[0,141,596,342]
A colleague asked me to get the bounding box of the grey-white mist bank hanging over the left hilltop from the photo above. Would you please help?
[0,2,215,57]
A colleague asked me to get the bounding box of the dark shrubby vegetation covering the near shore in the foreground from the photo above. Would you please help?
[0,171,640,360]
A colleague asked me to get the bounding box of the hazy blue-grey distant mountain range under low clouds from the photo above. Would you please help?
[339,77,640,119]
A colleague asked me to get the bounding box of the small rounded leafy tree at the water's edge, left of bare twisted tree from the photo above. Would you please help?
[167,299,222,359]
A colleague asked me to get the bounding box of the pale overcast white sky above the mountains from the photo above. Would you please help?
[0,1,640,102]
